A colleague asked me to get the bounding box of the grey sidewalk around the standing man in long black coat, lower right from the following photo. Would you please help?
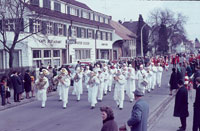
[148,90,195,131]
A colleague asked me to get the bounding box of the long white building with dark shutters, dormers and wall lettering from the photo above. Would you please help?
[0,0,114,68]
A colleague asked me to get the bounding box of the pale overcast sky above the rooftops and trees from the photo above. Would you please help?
[77,0,200,40]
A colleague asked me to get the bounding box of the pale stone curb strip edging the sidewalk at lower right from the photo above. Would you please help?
[148,95,175,130]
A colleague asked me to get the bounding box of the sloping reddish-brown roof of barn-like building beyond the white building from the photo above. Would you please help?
[110,20,137,40]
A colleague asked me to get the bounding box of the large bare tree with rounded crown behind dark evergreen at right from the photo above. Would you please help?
[148,9,187,53]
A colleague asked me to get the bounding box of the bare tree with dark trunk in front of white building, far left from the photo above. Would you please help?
[0,0,41,68]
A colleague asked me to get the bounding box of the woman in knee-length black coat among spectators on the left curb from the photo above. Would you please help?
[24,70,31,99]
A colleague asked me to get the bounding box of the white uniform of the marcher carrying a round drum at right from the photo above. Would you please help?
[137,69,147,93]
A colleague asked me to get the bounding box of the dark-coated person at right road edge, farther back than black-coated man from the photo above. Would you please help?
[169,68,178,95]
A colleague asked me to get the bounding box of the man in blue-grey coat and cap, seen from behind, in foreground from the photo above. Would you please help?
[127,90,149,131]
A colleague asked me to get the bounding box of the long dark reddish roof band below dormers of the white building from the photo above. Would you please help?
[26,4,113,29]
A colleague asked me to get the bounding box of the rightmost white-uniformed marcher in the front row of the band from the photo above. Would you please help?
[114,74,126,109]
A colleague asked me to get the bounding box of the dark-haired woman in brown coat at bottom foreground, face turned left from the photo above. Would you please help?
[100,107,118,131]
